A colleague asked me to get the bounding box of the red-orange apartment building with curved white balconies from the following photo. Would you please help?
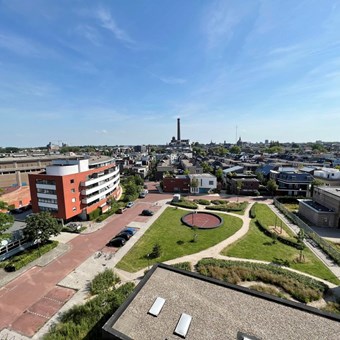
[29,157,121,221]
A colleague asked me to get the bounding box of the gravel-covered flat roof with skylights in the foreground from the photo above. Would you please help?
[103,264,340,340]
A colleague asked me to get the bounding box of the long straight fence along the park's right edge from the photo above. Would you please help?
[274,198,340,265]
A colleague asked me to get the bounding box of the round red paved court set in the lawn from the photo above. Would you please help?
[181,211,223,229]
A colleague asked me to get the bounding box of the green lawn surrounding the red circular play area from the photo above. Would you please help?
[117,208,242,272]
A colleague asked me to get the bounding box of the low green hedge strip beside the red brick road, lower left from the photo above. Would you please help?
[5,241,58,272]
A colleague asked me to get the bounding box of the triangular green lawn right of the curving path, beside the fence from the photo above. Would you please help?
[222,221,340,284]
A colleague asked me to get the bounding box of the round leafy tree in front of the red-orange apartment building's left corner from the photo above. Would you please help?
[24,211,61,243]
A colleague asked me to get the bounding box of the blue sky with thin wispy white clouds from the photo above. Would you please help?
[0,0,340,147]
